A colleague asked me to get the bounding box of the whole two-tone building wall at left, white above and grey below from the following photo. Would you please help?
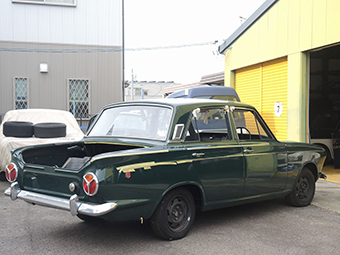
[0,0,123,127]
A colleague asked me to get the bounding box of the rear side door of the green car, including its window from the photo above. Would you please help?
[185,108,245,202]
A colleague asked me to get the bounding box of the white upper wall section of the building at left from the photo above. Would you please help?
[0,0,122,46]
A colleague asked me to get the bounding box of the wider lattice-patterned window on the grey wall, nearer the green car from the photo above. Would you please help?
[68,79,90,119]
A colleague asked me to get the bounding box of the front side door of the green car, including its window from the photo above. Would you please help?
[232,108,287,196]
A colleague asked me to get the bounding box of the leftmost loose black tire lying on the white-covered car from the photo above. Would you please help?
[2,121,34,137]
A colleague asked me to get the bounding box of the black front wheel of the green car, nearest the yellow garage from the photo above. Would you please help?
[286,168,315,207]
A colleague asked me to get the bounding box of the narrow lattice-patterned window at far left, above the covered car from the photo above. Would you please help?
[13,77,28,110]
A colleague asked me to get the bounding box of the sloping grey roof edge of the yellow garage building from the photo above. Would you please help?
[218,0,279,54]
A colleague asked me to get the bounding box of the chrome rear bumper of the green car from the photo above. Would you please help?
[4,182,117,216]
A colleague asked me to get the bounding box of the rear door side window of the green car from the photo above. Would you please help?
[185,108,230,141]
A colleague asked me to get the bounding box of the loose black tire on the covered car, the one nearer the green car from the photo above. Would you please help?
[34,122,66,138]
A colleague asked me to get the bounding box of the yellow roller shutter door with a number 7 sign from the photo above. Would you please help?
[235,57,288,140]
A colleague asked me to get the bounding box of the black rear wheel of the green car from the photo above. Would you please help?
[150,188,195,240]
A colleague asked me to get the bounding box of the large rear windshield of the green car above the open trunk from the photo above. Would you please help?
[88,105,172,140]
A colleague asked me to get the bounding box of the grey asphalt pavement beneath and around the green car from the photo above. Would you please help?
[0,167,340,255]
